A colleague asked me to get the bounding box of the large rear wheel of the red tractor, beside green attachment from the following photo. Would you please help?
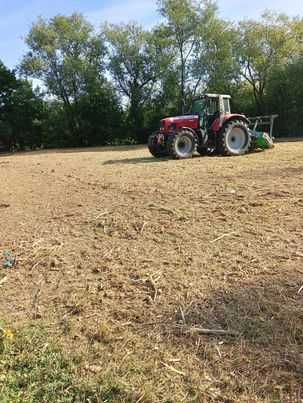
[218,120,252,156]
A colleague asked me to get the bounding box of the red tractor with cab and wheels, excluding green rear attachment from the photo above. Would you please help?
[148,94,252,159]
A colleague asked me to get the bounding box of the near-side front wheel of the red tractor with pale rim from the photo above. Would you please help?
[167,129,197,159]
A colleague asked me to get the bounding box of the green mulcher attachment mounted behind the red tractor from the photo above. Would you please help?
[249,115,278,150]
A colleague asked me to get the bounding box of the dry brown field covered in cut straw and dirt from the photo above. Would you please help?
[0,143,303,403]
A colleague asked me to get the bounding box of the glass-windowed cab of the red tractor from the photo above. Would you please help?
[192,94,231,129]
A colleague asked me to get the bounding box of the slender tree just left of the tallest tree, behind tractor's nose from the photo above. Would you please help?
[104,23,161,141]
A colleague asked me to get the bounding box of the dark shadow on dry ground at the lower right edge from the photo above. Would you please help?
[169,274,303,348]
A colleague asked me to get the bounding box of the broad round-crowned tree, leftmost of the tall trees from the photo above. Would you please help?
[21,14,105,145]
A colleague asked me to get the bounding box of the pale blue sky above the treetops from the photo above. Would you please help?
[0,0,303,68]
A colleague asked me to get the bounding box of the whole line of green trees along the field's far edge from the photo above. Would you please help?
[0,0,303,149]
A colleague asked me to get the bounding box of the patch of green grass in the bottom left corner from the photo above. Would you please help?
[0,329,132,403]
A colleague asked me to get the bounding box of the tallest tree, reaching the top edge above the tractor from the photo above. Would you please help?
[158,0,222,113]
